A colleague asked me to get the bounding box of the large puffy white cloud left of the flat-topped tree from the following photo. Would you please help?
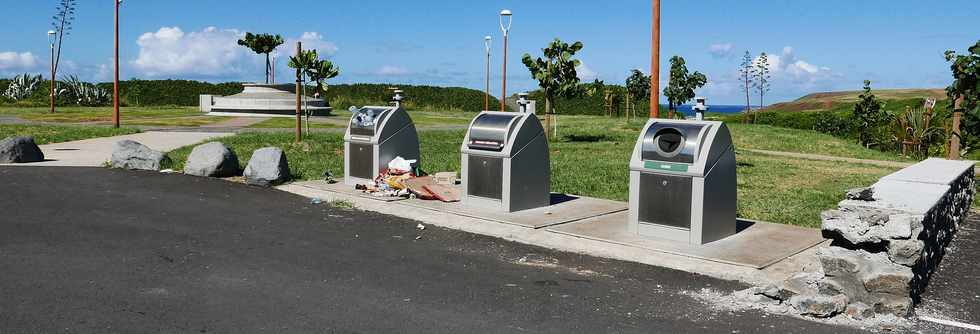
[130,27,250,77]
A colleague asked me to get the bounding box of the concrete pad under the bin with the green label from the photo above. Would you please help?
[547,212,824,269]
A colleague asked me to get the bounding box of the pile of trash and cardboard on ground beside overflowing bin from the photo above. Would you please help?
[354,157,460,202]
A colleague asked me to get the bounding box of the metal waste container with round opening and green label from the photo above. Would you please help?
[629,119,737,245]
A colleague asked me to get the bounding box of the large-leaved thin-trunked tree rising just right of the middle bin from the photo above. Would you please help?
[521,38,583,138]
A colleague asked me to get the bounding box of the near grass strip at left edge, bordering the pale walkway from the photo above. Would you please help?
[0,124,139,145]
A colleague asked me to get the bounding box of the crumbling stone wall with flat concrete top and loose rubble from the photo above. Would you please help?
[757,159,975,318]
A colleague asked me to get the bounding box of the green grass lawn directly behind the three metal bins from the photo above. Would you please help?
[171,113,896,227]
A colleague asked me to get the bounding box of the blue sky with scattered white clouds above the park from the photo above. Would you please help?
[0,0,980,104]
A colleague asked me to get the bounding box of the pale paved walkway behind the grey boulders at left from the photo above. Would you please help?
[0,131,233,167]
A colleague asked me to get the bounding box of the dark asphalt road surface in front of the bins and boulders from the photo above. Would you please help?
[0,167,916,333]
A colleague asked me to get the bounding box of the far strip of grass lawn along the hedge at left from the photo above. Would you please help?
[0,107,229,126]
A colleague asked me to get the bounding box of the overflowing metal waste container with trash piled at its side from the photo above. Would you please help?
[344,106,421,185]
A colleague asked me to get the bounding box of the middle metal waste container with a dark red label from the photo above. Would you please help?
[460,111,551,212]
